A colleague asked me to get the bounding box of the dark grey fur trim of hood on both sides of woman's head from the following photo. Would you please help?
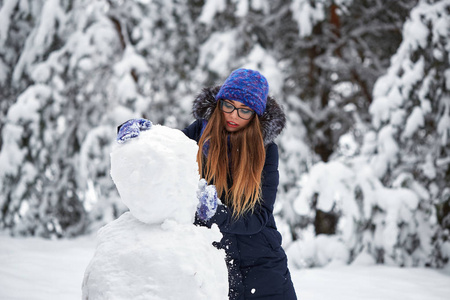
[192,86,286,146]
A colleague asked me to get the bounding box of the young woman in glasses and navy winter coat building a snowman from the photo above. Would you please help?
[183,69,297,300]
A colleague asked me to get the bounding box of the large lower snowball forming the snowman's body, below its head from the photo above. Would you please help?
[83,212,228,300]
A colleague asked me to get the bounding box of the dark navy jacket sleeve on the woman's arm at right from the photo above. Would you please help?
[206,143,279,235]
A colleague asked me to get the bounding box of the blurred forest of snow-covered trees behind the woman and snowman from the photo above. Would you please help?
[0,0,450,267]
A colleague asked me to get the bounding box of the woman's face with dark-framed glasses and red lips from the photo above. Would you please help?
[220,100,255,132]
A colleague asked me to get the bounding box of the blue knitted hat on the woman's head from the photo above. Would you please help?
[216,69,269,116]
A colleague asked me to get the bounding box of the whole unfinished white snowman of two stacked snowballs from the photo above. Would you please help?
[82,121,228,300]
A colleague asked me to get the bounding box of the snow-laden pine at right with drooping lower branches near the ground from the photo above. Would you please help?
[288,0,450,266]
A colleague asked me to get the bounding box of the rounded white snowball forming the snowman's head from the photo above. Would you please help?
[111,125,199,224]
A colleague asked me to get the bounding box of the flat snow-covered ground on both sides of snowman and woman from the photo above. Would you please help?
[0,235,450,300]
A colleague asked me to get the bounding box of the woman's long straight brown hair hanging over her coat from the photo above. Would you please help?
[197,106,266,218]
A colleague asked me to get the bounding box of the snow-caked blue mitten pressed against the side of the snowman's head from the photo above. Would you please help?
[197,179,217,222]
